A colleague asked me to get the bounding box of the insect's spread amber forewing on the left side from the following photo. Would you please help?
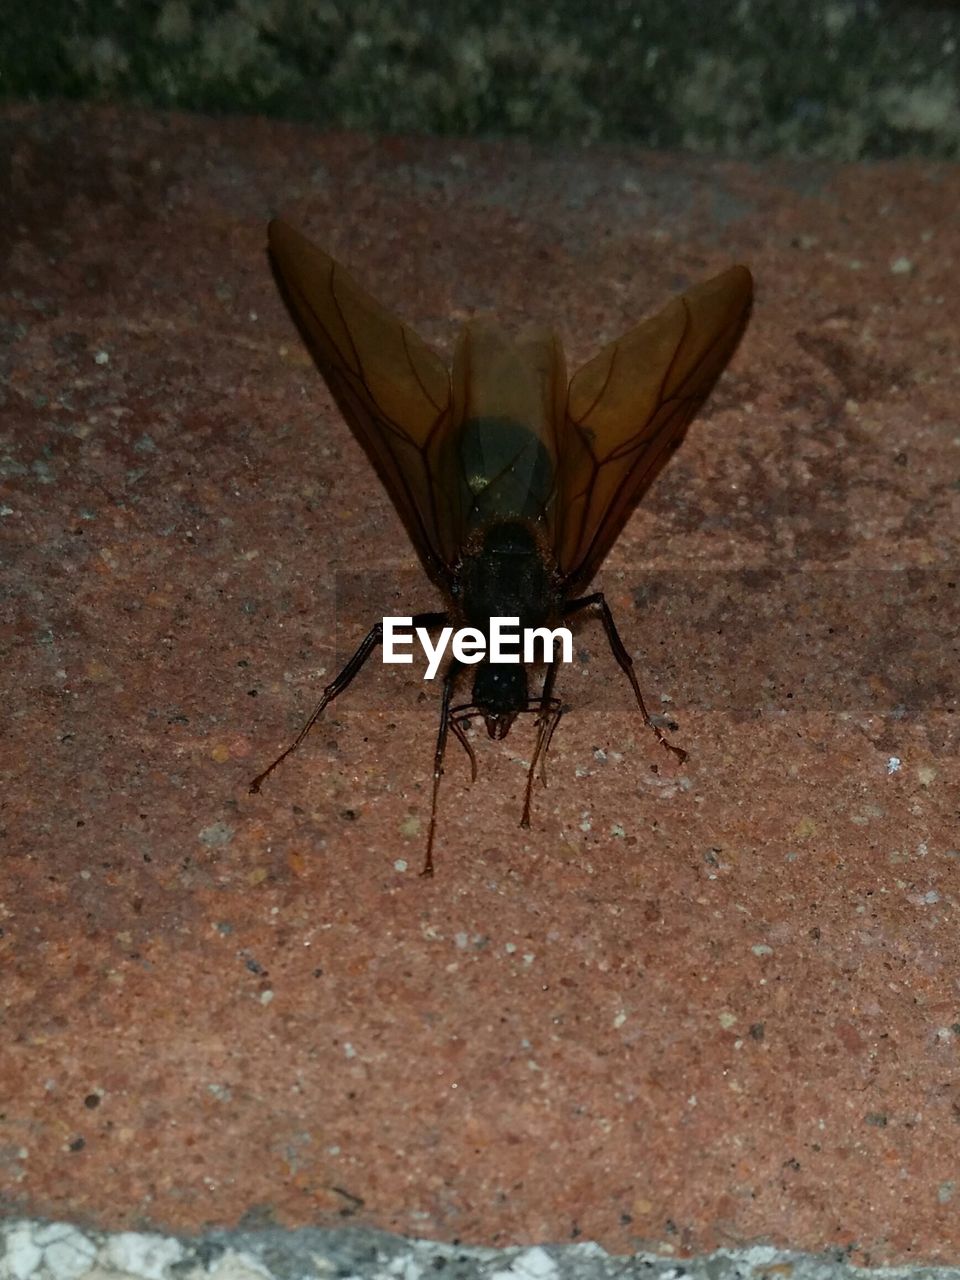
[268,219,457,586]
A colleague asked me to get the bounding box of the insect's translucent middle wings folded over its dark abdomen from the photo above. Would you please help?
[443,320,567,547]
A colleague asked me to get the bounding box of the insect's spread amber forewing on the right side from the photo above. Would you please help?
[557,266,753,590]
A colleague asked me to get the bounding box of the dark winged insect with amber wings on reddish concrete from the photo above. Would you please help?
[250,220,753,876]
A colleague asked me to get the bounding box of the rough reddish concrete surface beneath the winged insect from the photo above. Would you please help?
[0,106,960,1262]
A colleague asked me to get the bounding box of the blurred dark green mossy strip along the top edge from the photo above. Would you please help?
[0,0,960,160]
